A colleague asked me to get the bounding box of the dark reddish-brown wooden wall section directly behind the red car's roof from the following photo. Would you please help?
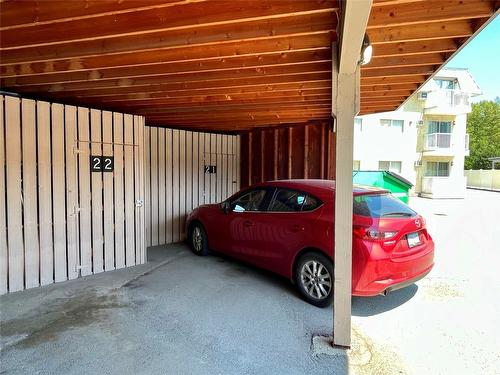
[237,122,335,187]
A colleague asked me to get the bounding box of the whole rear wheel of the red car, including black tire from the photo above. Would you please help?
[294,253,333,307]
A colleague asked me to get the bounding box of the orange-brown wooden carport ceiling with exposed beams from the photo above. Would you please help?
[0,0,498,131]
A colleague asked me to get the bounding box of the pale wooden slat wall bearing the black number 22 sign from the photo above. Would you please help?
[0,95,146,294]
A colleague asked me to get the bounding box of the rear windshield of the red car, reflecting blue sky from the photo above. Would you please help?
[353,194,417,218]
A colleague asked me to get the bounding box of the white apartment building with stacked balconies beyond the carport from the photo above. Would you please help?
[353,68,481,198]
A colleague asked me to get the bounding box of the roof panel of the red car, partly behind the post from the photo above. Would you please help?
[252,179,389,199]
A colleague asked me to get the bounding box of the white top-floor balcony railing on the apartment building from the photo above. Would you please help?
[424,89,471,115]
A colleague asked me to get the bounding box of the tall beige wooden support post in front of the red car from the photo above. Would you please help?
[332,0,372,347]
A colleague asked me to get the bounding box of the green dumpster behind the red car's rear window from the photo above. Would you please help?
[352,171,413,204]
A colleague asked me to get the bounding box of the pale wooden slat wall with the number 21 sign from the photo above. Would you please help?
[144,126,240,246]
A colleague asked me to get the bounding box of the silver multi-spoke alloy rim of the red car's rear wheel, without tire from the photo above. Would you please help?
[300,260,332,300]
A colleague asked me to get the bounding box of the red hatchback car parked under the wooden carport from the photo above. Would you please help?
[186,180,434,306]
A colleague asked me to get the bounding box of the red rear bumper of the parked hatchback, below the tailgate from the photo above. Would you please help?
[352,243,434,297]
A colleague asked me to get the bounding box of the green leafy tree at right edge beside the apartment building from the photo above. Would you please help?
[465,98,500,169]
